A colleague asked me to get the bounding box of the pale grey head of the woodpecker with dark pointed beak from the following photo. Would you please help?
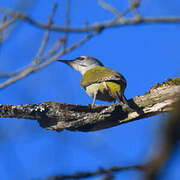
[58,56,104,75]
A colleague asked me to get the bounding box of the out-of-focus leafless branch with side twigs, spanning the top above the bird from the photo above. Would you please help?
[0,0,180,88]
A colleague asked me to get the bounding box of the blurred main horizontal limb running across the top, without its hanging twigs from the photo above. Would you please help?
[0,6,180,33]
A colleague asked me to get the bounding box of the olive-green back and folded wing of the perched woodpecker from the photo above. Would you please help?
[81,66,126,88]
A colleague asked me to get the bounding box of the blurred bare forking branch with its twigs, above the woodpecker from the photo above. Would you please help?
[0,0,180,89]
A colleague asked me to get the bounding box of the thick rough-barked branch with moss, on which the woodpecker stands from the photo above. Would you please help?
[0,78,180,132]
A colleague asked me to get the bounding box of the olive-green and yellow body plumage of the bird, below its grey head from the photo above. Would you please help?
[81,66,127,104]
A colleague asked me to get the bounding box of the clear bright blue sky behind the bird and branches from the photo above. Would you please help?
[0,0,180,180]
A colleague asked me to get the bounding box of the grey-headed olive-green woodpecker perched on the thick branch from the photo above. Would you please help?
[58,56,128,107]
